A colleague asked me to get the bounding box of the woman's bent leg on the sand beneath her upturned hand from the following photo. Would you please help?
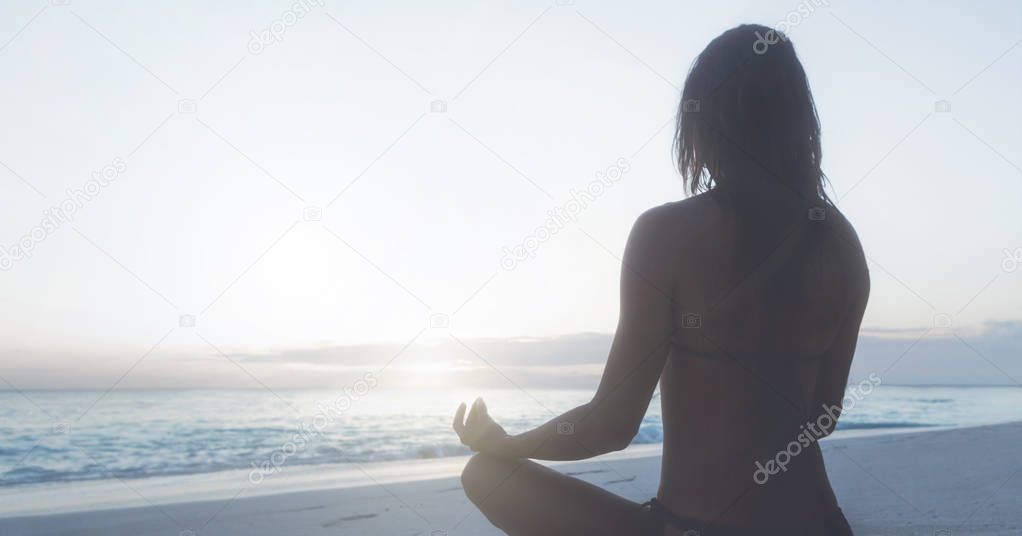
[461,454,656,536]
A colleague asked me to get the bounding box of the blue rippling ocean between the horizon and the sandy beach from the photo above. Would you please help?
[0,385,1022,487]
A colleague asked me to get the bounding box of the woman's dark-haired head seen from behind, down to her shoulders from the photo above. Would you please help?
[675,25,828,202]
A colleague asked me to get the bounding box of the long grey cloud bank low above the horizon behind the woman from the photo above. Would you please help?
[229,321,1022,387]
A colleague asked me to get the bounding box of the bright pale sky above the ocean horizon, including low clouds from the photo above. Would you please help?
[0,0,1022,389]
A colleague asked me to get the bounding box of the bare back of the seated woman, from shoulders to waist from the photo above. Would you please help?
[658,190,868,527]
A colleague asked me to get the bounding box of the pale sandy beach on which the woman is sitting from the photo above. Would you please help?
[0,422,1022,536]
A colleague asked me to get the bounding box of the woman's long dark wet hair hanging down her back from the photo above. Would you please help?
[675,25,835,351]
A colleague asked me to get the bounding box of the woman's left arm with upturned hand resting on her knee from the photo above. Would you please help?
[455,207,678,460]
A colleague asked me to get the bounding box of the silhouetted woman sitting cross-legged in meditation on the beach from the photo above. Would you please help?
[454,26,870,536]
